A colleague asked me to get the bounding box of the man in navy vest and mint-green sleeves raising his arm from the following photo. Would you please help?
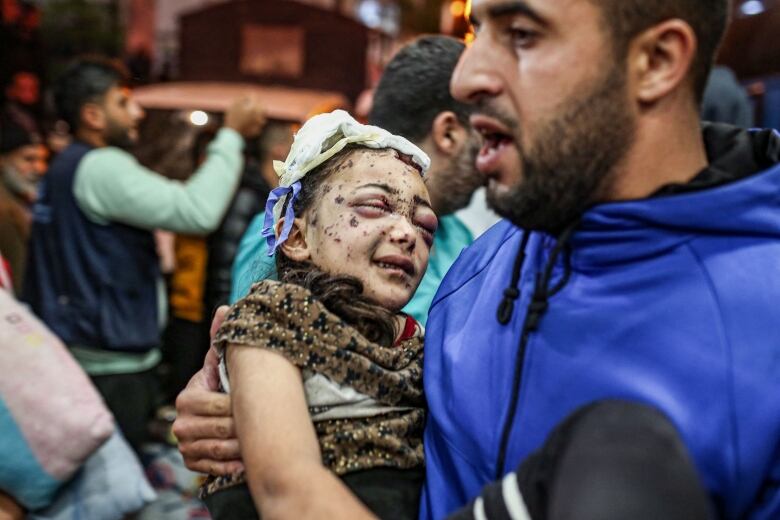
[24,54,264,448]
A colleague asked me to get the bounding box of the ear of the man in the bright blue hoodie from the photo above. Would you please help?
[629,18,697,104]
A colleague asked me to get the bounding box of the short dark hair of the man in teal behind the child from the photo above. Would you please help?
[368,35,472,141]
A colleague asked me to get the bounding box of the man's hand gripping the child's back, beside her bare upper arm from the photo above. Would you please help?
[173,306,244,475]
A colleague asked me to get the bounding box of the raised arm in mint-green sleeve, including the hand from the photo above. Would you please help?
[74,100,262,234]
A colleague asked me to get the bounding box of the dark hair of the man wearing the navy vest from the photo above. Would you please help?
[54,56,129,132]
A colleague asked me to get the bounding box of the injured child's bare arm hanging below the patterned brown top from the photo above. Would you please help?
[227,345,373,520]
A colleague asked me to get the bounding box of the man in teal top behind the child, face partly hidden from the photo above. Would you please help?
[230,35,484,325]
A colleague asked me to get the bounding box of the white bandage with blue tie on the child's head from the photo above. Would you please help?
[263,110,431,255]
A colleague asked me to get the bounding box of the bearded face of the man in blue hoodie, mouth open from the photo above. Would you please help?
[451,0,635,232]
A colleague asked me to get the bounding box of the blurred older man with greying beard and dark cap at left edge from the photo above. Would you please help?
[0,118,47,294]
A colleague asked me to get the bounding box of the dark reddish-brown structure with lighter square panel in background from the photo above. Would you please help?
[179,0,374,100]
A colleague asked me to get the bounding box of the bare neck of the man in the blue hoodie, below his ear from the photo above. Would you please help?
[608,104,707,201]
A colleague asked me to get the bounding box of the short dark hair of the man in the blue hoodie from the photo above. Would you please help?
[591,0,731,101]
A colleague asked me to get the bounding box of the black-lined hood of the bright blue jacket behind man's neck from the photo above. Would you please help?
[570,125,780,267]
